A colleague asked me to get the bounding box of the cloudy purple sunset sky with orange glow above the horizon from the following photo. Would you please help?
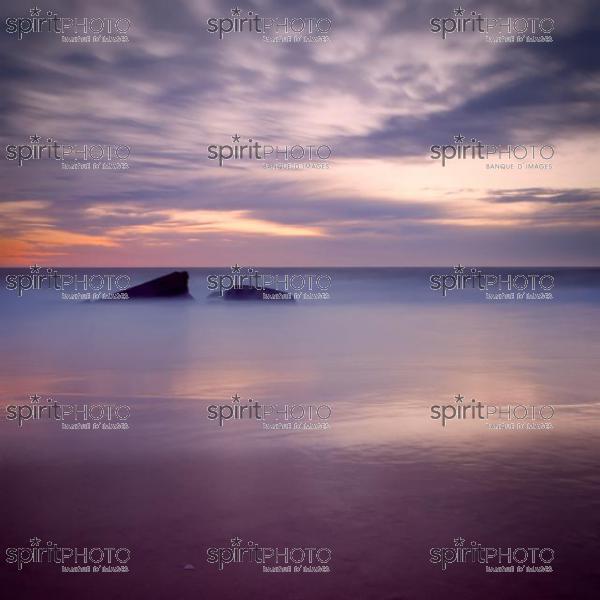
[0,0,600,267]
